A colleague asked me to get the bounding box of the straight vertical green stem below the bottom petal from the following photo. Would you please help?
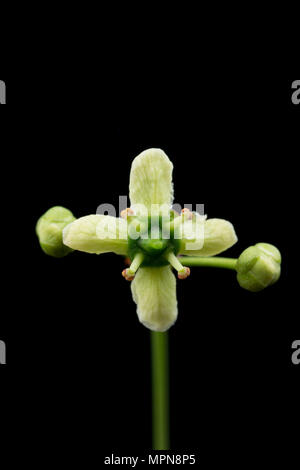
[151,331,170,450]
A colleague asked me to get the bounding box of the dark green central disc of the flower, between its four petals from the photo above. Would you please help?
[128,216,180,267]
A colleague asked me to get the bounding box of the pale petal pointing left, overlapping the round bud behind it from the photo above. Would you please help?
[63,214,128,255]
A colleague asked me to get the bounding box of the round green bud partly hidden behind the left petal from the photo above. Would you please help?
[35,206,76,258]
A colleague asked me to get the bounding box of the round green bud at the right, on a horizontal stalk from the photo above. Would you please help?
[236,243,281,292]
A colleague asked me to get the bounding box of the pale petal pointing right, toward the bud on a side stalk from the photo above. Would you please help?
[180,219,237,256]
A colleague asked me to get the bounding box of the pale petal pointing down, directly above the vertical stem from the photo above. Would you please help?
[131,266,177,331]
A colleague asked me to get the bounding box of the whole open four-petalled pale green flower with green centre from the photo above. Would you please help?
[63,149,237,331]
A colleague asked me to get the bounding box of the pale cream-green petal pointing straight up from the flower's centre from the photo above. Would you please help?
[129,149,173,215]
